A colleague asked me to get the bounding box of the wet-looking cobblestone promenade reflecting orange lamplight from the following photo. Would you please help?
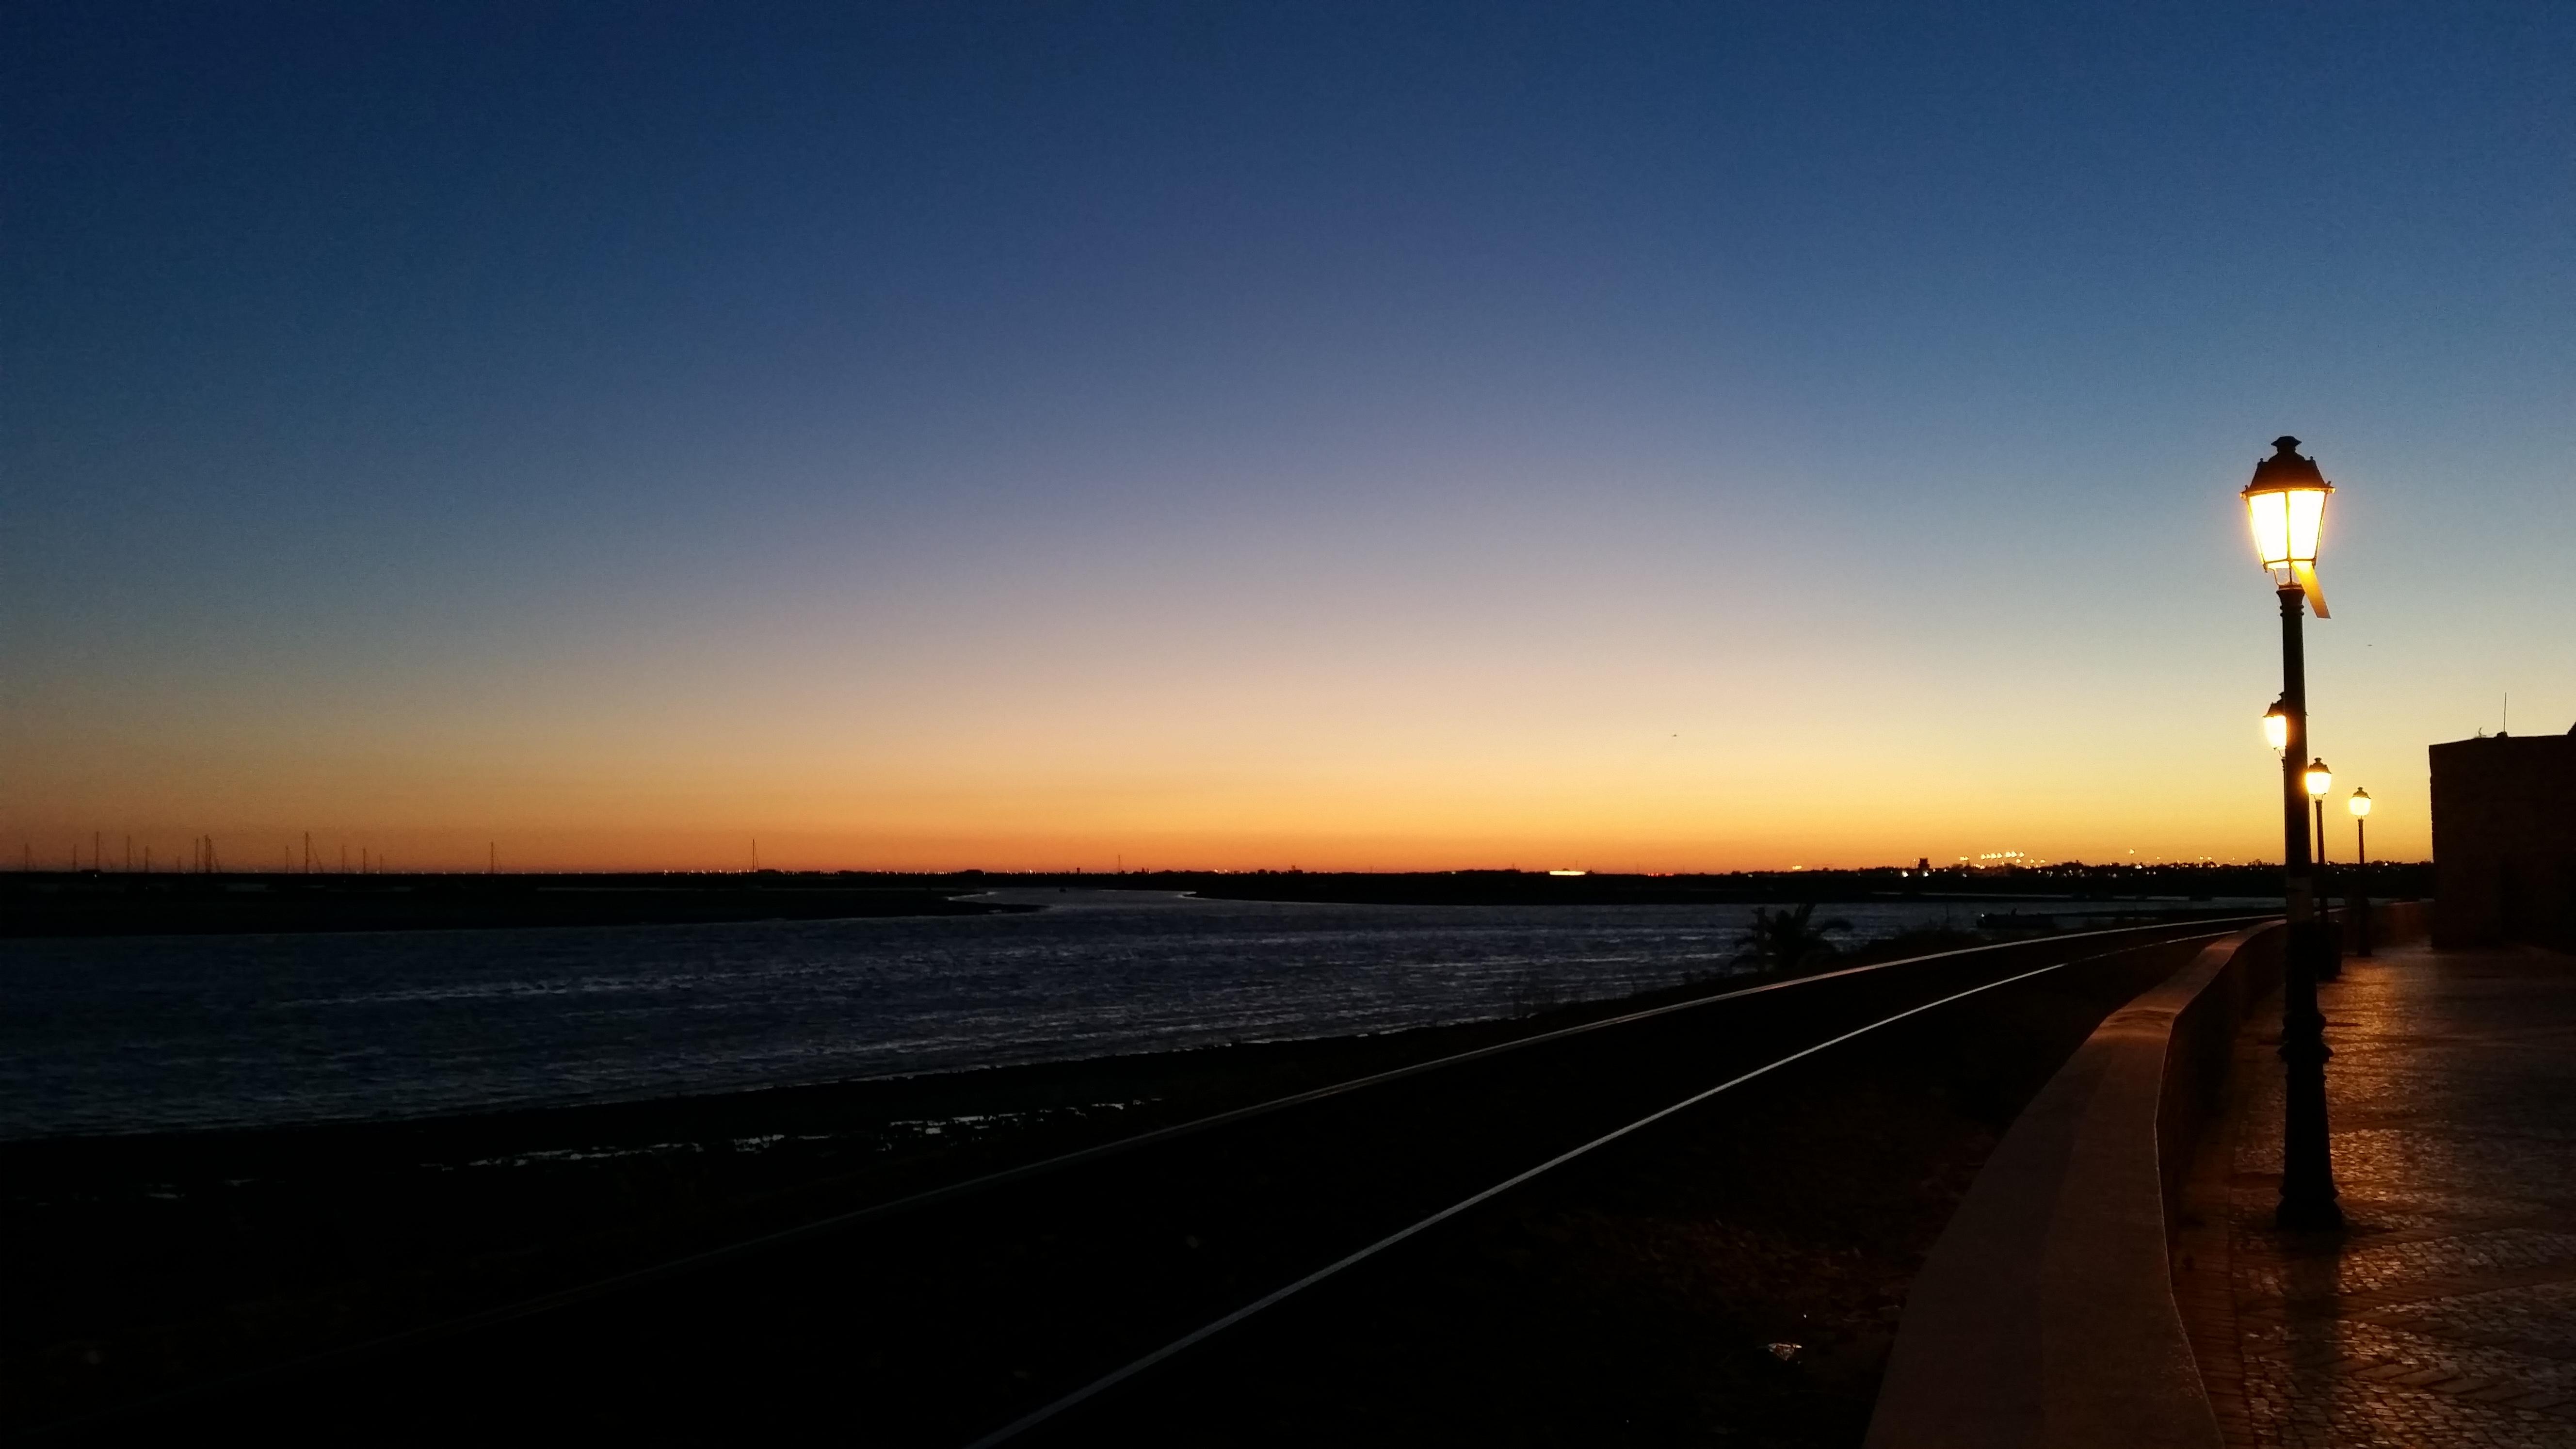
[2174,946,2576,1449]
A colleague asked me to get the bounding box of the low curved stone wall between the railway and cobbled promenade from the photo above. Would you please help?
[1868,902,2427,1449]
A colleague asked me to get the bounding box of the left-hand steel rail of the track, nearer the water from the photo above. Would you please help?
[33,915,2272,1439]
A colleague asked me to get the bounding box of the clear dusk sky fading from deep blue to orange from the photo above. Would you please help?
[0,0,2576,869]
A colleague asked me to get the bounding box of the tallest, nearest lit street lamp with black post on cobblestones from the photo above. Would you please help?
[2241,438,2344,1227]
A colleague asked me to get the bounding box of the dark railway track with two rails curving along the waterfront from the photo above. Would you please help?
[35,923,2256,1449]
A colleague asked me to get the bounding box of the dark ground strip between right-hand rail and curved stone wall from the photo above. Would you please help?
[1056,923,2225,1449]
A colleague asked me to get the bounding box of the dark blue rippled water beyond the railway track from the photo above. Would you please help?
[0,889,1976,1140]
